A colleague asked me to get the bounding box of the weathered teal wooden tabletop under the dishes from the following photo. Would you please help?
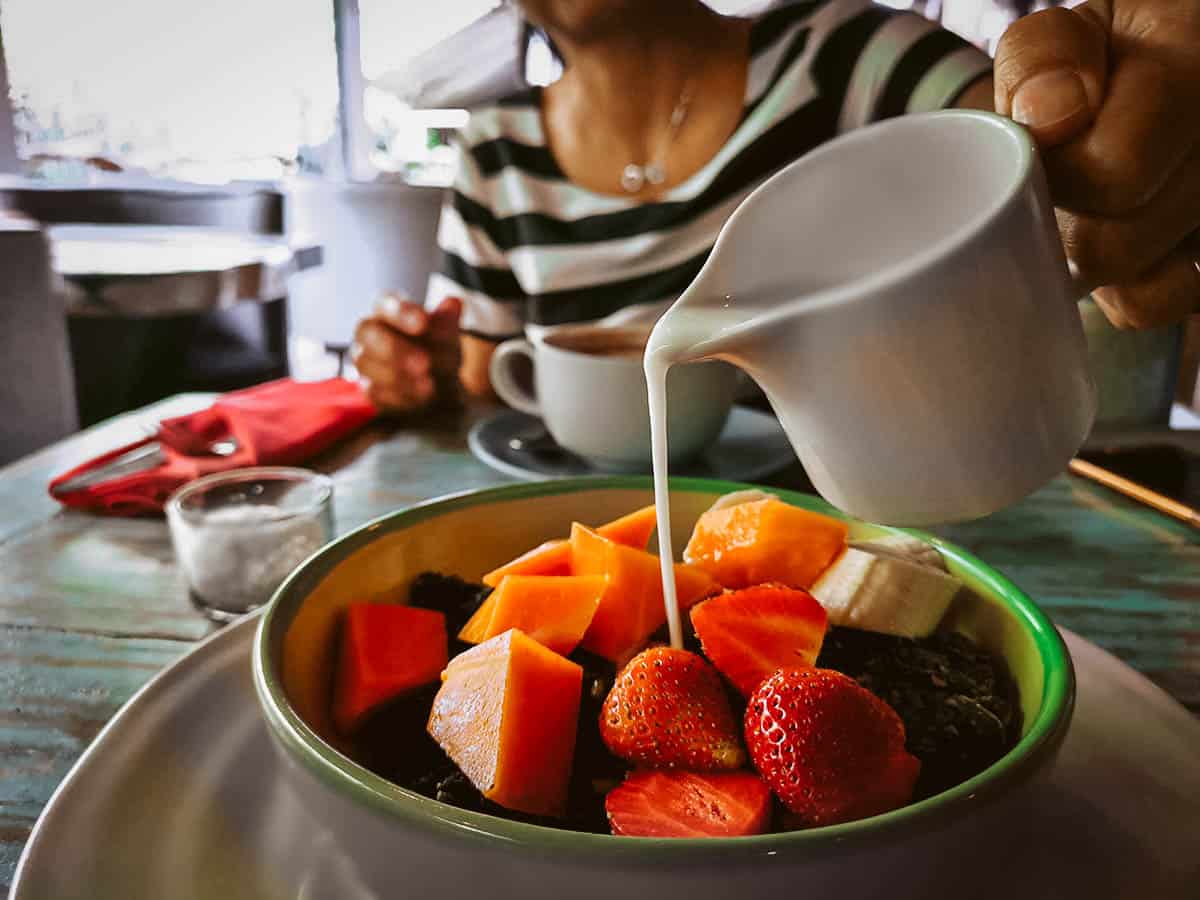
[0,396,1200,892]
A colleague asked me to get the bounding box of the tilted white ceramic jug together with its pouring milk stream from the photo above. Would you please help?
[644,110,1096,647]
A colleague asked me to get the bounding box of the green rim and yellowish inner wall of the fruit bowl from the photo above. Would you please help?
[253,478,1075,865]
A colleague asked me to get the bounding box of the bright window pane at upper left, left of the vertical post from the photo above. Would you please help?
[0,0,338,181]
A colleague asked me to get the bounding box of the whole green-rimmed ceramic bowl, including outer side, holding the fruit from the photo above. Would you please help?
[253,478,1074,899]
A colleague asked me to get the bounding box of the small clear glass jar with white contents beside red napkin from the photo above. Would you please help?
[167,467,334,622]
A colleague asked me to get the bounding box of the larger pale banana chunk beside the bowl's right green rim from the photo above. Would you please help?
[810,547,962,637]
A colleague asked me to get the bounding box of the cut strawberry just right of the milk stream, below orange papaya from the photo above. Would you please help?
[691,584,827,696]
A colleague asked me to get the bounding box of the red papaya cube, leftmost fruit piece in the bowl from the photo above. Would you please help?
[334,604,446,734]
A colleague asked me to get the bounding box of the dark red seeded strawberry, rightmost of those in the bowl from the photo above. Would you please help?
[745,668,920,826]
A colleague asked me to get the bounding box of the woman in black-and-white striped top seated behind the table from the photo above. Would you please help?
[355,0,1200,410]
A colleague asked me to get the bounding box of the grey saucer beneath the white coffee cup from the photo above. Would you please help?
[467,407,796,481]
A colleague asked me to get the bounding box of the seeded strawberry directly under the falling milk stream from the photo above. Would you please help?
[600,647,745,769]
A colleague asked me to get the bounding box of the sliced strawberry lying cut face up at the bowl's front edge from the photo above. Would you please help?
[604,772,770,838]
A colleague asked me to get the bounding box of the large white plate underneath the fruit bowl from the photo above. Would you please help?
[10,616,1200,900]
